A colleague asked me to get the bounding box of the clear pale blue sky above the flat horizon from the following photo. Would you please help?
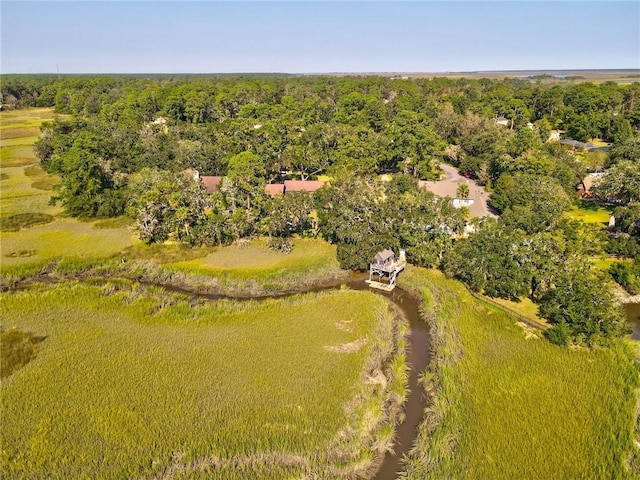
[0,0,640,73]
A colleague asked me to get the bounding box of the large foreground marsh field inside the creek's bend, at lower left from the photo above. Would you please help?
[0,282,402,479]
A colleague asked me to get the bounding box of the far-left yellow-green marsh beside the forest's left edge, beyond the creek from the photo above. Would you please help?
[0,108,134,275]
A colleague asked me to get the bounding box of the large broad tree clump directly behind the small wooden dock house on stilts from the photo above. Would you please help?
[315,174,465,270]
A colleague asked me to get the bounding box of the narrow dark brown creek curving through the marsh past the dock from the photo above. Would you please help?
[18,274,431,480]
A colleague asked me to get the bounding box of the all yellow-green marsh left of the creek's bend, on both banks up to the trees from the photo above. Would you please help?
[0,109,406,479]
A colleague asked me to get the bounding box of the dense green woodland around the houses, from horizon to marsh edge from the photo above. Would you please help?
[3,76,640,344]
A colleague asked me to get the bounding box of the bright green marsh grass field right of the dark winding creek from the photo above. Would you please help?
[401,269,639,480]
